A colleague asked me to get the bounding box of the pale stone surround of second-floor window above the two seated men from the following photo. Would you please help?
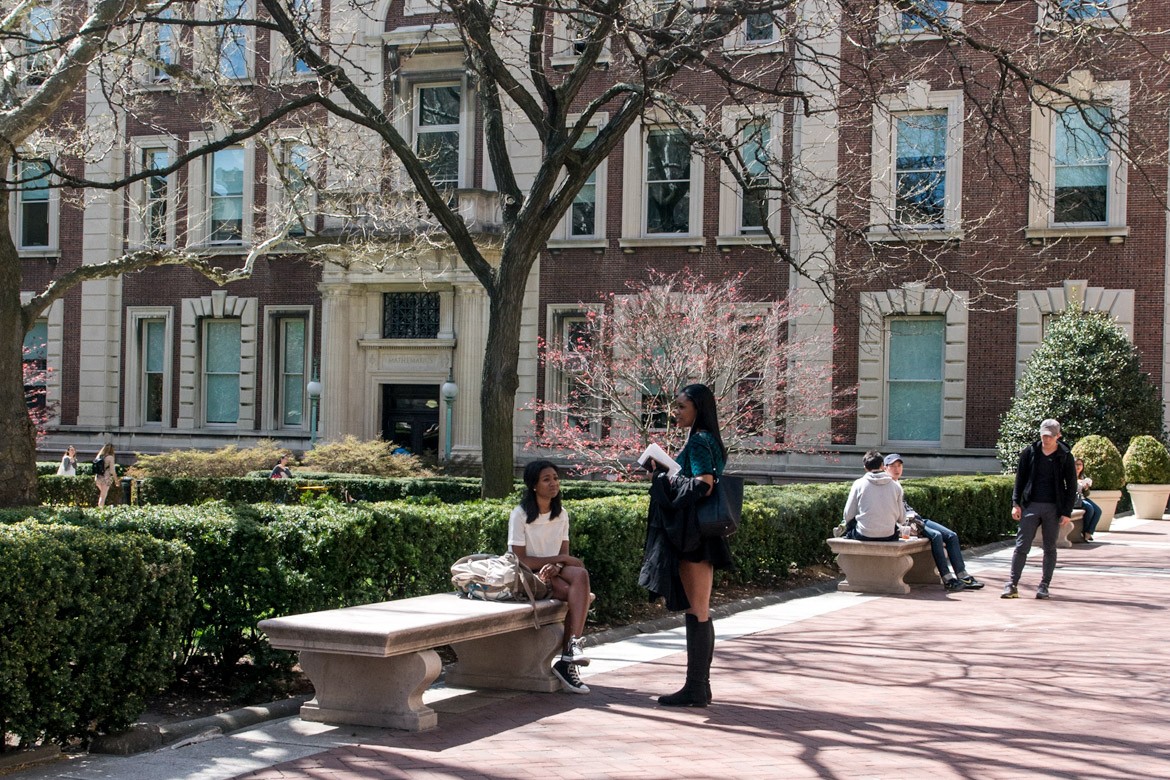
[867,87,964,242]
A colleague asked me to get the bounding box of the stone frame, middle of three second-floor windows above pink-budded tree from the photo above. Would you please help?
[619,106,707,251]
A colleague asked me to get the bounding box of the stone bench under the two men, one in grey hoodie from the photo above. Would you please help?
[827,538,940,594]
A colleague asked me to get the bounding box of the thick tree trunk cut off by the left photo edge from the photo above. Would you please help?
[0,195,37,506]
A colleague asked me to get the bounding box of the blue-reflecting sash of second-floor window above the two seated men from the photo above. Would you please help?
[894,111,947,226]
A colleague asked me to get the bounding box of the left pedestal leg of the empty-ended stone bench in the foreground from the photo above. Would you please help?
[301,650,442,731]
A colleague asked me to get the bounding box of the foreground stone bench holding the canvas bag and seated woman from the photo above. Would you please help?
[259,593,567,731]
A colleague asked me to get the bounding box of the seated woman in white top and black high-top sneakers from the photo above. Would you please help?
[508,461,590,693]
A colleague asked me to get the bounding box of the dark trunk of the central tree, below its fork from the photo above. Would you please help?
[480,255,532,498]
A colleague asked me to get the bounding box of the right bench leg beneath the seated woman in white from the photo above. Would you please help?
[443,624,564,693]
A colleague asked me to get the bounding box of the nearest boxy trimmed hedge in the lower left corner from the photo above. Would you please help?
[0,520,192,751]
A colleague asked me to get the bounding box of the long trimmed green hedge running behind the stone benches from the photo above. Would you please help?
[0,475,1016,711]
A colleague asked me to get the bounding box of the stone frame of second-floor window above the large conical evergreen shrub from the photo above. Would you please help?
[1024,71,1129,243]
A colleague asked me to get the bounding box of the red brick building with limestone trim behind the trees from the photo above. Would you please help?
[20,0,1170,478]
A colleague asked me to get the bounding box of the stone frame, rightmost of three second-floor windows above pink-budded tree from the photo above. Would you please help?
[715,103,784,246]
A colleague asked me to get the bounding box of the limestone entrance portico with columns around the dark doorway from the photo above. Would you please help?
[319,250,538,461]
